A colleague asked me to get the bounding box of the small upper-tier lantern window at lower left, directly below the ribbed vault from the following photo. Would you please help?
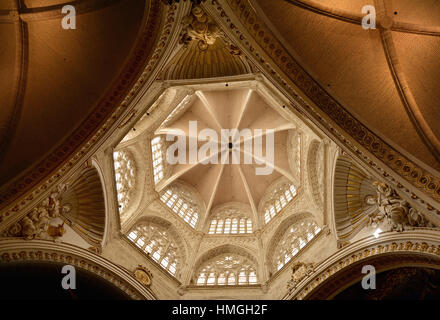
[160,188,199,228]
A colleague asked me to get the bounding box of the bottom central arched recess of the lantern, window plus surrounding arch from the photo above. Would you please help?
[192,245,258,285]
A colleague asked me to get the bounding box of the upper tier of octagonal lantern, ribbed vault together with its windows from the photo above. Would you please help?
[113,79,312,234]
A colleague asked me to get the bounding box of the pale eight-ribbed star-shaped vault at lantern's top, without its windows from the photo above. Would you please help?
[152,85,297,228]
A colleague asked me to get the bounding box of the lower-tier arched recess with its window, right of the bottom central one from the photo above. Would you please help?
[266,212,321,274]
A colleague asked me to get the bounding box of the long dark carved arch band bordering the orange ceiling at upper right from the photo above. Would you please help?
[205,0,440,213]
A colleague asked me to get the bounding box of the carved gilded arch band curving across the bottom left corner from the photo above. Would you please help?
[0,240,156,300]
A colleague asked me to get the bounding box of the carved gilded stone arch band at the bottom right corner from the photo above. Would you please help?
[285,230,440,300]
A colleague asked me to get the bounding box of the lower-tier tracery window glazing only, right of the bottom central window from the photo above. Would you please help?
[273,219,321,270]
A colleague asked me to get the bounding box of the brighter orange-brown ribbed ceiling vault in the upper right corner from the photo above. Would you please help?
[252,0,440,170]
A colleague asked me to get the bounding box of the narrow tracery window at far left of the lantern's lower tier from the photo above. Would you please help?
[113,151,135,214]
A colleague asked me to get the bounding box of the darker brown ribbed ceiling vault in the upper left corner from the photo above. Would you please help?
[0,0,149,186]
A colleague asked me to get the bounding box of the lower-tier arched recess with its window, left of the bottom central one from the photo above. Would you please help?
[127,216,187,278]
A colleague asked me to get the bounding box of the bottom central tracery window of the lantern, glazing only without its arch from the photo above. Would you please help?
[196,253,258,286]
